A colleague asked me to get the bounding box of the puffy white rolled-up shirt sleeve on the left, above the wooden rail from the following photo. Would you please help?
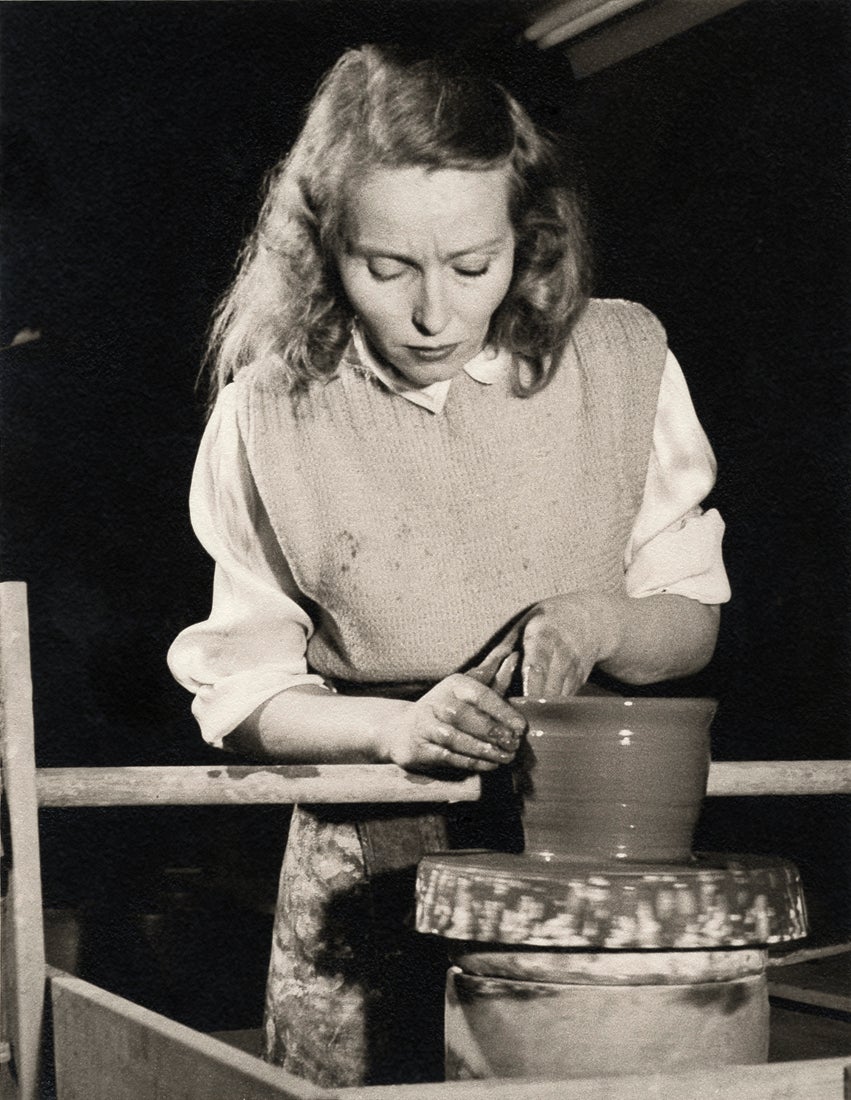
[168,385,323,746]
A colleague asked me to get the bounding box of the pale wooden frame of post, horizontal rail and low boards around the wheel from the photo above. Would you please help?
[0,582,851,1100]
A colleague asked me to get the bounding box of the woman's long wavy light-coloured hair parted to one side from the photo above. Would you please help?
[205,46,589,404]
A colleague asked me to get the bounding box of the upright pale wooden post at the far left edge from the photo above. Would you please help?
[0,582,45,1100]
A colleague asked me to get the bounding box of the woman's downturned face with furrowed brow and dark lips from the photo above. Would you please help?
[336,162,515,386]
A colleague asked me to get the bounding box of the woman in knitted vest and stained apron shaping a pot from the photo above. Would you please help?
[169,46,729,1086]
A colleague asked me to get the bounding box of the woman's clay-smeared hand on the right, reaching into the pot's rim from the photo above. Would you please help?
[512,593,617,699]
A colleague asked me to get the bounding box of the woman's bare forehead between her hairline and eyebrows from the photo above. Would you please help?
[346,167,511,249]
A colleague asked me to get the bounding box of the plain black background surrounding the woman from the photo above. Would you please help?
[0,0,851,1027]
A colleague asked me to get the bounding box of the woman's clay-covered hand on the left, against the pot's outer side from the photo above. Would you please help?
[380,655,526,771]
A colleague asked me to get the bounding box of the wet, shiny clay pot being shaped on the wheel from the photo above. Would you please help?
[511,695,717,864]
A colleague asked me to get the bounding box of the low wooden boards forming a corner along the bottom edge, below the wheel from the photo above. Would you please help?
[49,975,851,1100]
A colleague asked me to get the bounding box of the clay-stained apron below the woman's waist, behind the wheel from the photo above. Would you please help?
[264,712,523,1088]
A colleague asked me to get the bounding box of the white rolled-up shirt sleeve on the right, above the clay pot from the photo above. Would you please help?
[625,352,730,604]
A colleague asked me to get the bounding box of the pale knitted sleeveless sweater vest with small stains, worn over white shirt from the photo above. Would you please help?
[236,300,666,683]
